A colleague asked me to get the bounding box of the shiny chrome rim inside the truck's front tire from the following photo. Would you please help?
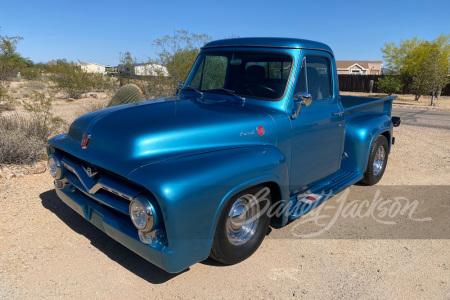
[226,194,260,246]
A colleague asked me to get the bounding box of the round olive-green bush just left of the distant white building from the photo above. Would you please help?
[50,62,92,99]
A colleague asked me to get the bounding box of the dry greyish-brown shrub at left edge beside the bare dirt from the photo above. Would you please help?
[0,113,44,164]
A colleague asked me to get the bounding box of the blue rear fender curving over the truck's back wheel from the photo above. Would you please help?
[341,114,392,173]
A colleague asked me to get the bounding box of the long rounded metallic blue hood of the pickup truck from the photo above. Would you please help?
[49,95,277,176]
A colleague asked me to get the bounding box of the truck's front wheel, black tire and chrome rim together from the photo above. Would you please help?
[210,186,271,265]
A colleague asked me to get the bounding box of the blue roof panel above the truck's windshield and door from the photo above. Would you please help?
[202,37,333,54]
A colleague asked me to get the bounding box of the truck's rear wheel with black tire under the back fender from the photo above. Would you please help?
[361,135,389,185]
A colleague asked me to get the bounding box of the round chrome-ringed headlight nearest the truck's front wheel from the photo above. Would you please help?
[130,197,155,232]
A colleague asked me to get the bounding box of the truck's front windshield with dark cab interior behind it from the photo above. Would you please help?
[183,51,292,100]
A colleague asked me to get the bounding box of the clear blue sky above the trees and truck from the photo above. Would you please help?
[0,0,450,65]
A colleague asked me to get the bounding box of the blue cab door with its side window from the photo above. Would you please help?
[290,50,344,193]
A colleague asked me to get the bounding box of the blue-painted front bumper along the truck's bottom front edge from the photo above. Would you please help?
[55,181,175,272]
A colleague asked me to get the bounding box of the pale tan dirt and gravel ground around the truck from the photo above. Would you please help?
[0,95,450,299]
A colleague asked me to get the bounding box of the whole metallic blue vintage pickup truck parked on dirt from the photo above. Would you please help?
[47,38,400,272]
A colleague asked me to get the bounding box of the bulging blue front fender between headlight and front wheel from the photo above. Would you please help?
[127,145,289,270]
